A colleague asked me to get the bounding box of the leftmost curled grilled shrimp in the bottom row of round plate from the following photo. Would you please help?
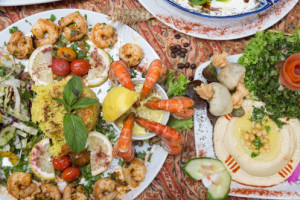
[7,172,37,199]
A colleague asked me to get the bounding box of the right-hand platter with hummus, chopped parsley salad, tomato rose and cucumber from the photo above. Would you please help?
[183,28,300,199]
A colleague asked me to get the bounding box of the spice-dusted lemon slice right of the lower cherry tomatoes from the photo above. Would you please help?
[88,131,113,176]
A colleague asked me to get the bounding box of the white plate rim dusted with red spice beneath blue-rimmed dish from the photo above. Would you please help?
[139,0,298,40]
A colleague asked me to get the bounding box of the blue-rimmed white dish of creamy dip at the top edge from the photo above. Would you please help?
[165,0,280,19]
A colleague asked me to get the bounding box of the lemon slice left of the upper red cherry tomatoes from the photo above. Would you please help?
[28,45,53,85]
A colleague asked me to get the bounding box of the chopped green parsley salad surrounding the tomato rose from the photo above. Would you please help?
[238,28,300,124]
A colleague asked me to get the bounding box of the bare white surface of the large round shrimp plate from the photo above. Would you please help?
[0,9,168,200]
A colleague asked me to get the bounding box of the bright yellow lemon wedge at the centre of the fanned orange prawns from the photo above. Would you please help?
[102,87,140,122]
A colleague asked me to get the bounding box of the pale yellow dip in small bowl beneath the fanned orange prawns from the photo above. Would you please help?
[115,84,166,136]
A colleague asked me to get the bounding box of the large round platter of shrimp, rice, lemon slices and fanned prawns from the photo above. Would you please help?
[0,9,194,200]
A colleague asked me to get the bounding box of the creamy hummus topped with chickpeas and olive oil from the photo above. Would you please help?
[214,100,300,186]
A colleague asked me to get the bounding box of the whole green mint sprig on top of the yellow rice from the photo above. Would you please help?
[52,76,99,153]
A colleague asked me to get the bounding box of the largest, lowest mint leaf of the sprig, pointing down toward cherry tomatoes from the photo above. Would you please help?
[63,114,87,153]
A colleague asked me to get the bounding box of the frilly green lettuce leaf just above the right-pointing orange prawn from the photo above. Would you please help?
[166,69,190,97]
